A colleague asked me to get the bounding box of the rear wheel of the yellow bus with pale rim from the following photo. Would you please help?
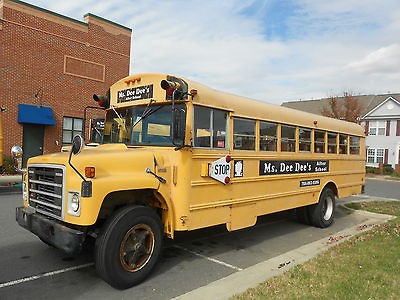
[308,188,336,228]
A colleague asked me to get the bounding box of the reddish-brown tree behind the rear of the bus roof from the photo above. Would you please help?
[321,92,362,123]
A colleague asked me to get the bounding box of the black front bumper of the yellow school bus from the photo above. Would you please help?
[16,206,86,255]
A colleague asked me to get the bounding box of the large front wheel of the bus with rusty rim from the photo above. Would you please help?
[95,206,163,289]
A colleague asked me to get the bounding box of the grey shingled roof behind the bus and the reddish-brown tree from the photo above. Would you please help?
[282,93,400,117]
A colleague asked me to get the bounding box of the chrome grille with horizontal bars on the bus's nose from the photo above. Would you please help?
[28,165,65,220]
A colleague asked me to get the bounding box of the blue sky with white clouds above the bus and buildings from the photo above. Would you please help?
[26,0,400,104]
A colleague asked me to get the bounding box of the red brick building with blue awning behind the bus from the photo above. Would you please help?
[0,0,132,162]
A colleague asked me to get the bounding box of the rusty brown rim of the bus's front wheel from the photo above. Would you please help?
[119,224,155,272]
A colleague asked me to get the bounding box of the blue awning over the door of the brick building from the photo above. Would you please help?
[18,104,56,126]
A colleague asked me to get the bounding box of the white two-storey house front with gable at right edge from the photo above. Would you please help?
[360,96,400,168]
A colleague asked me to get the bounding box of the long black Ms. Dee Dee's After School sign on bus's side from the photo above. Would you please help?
[260,160,329,175]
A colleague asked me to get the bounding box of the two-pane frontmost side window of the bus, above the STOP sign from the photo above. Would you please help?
[194,106,228,149]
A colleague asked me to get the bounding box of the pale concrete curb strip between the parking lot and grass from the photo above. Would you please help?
[173,205,396,300]
